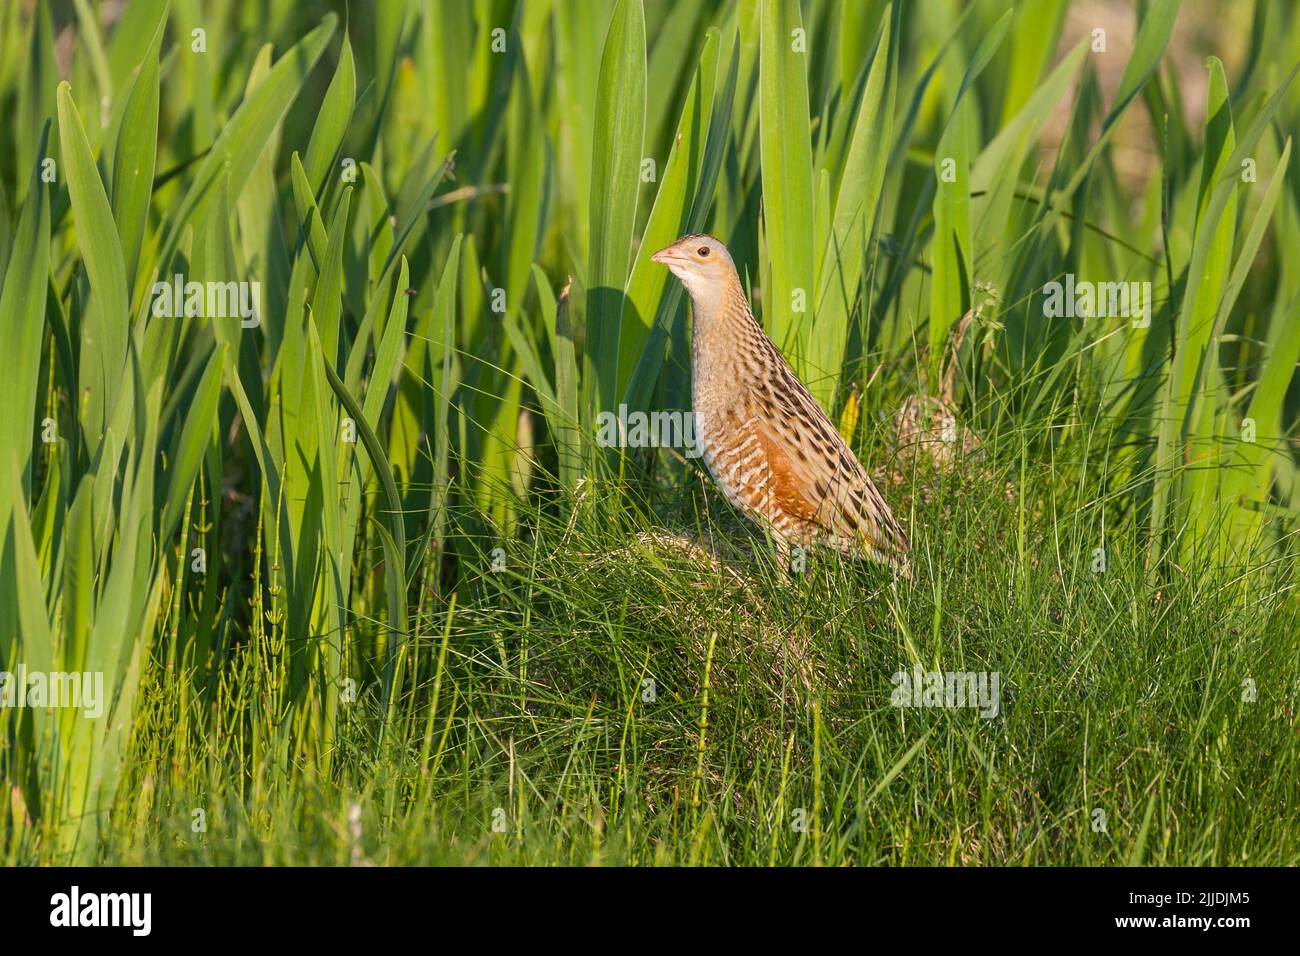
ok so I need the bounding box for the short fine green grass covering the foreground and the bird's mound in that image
[20,434,1300,865]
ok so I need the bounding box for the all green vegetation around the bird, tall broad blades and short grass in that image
[0,0,1300,865]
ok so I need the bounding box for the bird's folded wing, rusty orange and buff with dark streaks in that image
[746,363,907,564]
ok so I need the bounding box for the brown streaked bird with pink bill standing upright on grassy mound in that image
[650,233,910,576]
